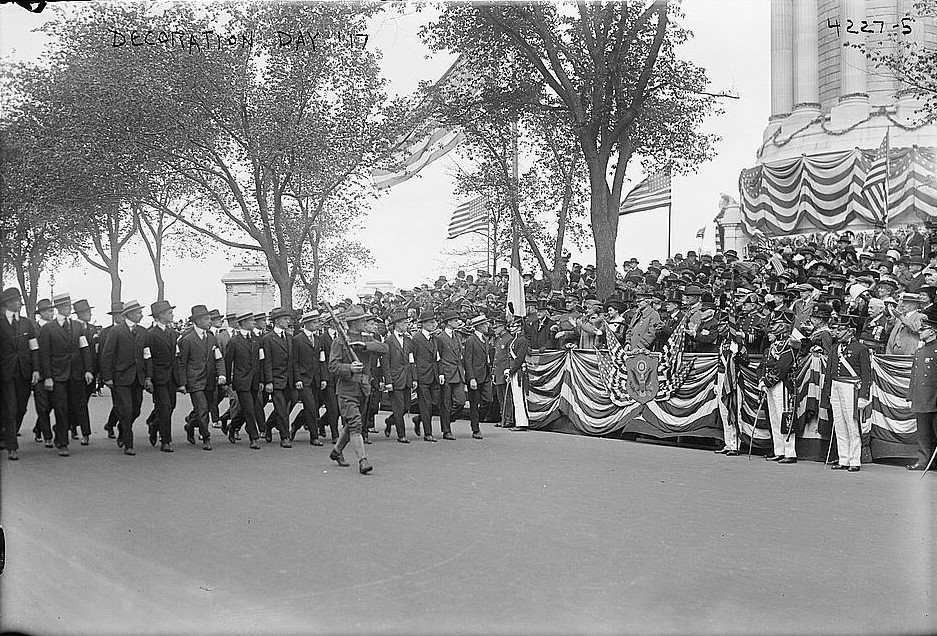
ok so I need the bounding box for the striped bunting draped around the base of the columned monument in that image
[739,148,937,236]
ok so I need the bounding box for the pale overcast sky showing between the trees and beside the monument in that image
[0,0,770,323]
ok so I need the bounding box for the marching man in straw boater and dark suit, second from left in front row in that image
[39,293,94,457]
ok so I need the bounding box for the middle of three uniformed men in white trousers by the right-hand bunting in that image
[758,312,797,464]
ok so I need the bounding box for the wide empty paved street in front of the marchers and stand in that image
[0,398,937,634]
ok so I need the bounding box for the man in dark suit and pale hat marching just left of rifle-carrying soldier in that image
[290,310,324,446]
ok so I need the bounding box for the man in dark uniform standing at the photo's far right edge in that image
[908,307,937,470]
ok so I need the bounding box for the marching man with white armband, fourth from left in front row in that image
[143,300,185,453]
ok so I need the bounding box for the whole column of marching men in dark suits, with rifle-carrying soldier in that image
[0,288,527,474]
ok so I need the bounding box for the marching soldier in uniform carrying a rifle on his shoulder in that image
[329,305,387,475]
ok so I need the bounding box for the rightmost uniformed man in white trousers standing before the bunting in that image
[829,314,872,472]
